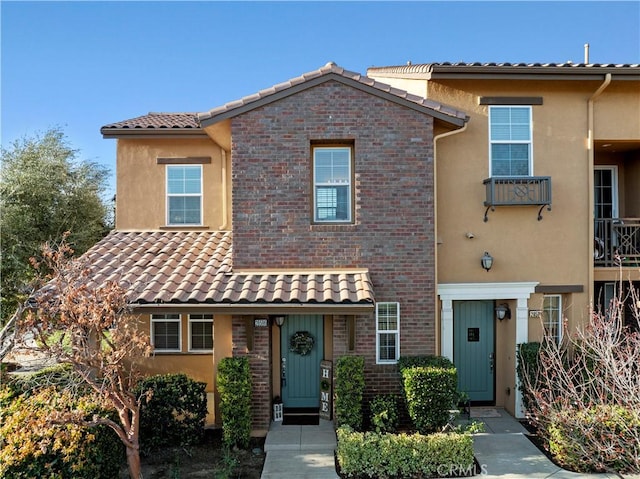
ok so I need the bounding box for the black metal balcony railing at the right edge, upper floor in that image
[593,218,640,267]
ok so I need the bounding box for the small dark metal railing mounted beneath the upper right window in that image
[483,176,551,221]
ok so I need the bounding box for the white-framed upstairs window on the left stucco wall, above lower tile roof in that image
[167,165,202,225]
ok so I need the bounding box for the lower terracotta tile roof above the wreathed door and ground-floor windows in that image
[83,231,374,305]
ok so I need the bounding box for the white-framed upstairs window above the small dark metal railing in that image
[489,106,533,176]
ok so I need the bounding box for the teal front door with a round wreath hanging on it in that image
[280,315,324,408]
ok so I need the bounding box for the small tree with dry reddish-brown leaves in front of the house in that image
[18,241,151,479]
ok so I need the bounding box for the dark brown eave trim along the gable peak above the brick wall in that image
[198,72,467,128]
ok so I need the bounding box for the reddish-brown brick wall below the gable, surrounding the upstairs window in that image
[232,81,435,408]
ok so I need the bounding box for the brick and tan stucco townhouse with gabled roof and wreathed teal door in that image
[90,63,467,434]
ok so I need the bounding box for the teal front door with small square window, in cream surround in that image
[453,301,495,403]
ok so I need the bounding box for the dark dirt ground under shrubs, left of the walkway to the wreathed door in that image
[120,431,265,479]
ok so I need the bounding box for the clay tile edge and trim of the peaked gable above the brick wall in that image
[198,62,467,126]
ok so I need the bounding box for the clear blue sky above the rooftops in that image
[0,0,640,197]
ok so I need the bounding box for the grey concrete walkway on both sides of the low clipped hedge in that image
[261,408,640,479]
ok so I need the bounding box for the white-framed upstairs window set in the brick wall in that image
[313,146,351,223]
